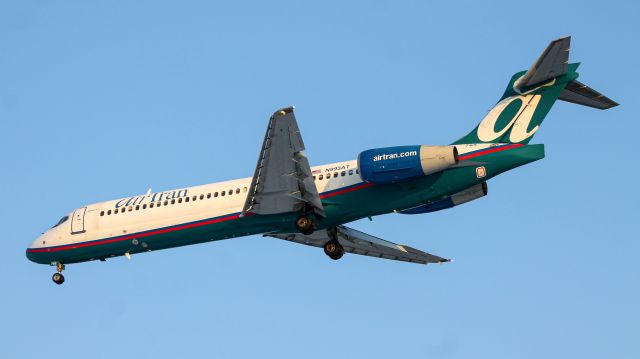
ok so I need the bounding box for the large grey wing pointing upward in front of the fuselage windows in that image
[242,107,325,217]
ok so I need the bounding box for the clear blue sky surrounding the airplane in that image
[0,1,640,358]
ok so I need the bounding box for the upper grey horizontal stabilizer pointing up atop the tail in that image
[514,36,571,89]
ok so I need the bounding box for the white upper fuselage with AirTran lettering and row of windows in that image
[30,160,362,256]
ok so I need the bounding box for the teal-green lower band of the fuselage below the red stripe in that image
[27,145,544,264]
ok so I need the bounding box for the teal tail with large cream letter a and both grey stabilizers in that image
[453,36,618,145]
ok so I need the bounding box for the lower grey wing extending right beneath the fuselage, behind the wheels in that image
[265,226,450,264]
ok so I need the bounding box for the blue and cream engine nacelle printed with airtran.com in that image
[358,145,458,184]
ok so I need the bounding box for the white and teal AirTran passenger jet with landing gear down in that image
[26,37,618,284]
